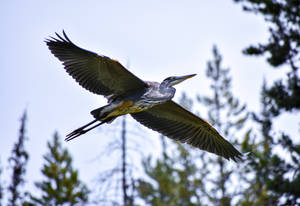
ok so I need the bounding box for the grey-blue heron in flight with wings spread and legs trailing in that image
[45,31,242,161]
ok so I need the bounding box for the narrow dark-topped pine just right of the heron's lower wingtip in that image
[240,80,279,206]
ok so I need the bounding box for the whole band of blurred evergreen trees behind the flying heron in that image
[0,0,300,206]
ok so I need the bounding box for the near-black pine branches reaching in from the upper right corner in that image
[234,0,300,114]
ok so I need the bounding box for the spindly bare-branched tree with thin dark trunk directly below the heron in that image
[94,116,141,206]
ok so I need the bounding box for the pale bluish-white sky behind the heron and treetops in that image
[0,0,299,203]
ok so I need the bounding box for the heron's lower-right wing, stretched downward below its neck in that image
[131,101,242,161]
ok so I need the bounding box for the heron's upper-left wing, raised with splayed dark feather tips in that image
[45,31,146,96]
